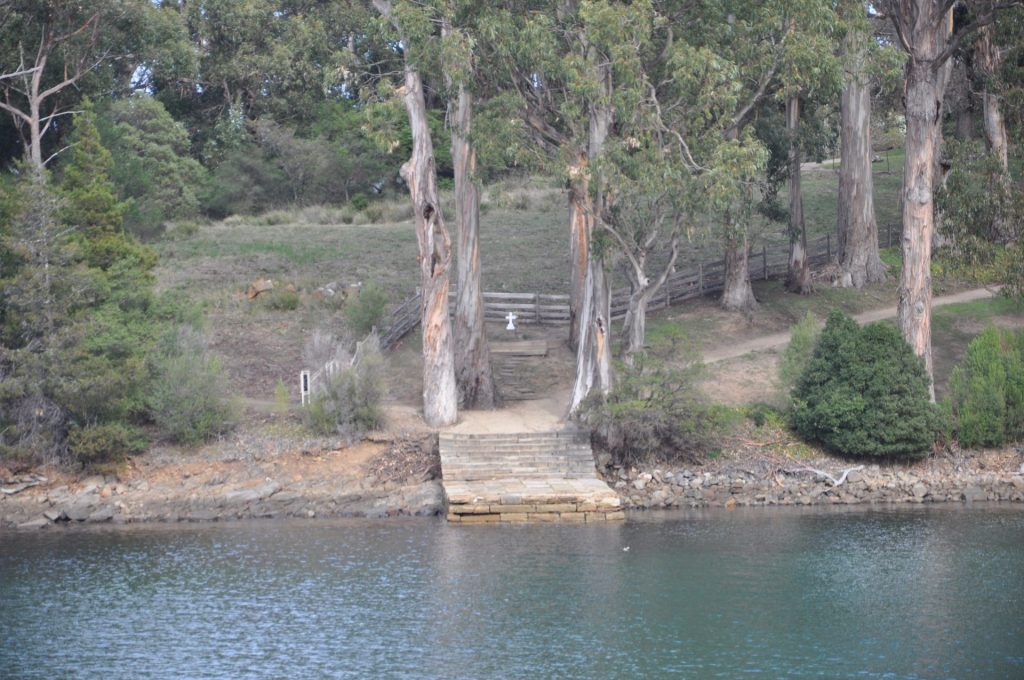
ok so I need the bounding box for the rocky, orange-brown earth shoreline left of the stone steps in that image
[0,437,444,529]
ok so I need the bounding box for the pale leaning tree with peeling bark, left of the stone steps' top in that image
[374,0,459,427]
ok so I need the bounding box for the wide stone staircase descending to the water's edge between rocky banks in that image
[439,429,624,523]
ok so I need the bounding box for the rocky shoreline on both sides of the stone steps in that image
[0,436,1024,529]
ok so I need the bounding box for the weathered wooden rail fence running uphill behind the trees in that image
[381,224,899,349]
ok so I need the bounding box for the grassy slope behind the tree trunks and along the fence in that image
[158,152,1019,409]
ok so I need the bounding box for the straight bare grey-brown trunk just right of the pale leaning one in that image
[451,86,498,409]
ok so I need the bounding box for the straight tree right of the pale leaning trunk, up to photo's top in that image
[442,5,498,409]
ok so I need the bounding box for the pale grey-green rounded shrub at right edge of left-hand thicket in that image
[146,327,236,445]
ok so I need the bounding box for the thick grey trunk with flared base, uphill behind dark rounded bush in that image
[837,11,886,288]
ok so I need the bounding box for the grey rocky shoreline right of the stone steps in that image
[598,453,1024,509]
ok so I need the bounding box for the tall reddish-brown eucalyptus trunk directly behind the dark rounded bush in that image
[880,0,1022,399]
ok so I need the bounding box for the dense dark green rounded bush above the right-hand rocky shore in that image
[792,311,940,457]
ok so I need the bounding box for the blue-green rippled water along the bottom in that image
[0,507,1024,679]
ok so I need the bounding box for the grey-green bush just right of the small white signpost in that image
[305,334,384,441]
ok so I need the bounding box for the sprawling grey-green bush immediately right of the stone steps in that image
[578,330,726,465]
